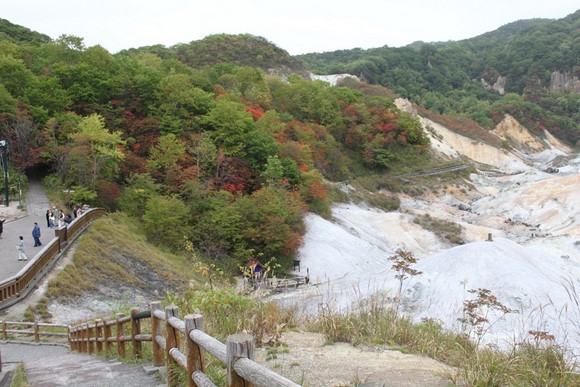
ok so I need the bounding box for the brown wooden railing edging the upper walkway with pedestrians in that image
[0,208,106,310]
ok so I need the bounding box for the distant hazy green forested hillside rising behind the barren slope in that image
[299,11,580,145]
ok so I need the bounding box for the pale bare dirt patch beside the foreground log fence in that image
[255,332,454,387]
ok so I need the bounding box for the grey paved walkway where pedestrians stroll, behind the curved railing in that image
[0,180,55,281]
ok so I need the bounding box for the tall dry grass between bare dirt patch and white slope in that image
[309,294,580,386]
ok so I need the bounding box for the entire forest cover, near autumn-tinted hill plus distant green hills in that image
[0,12,580,267]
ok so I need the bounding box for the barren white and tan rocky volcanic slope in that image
[276,101,580,366]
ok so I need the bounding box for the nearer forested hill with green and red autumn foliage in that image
[0,21,428,268]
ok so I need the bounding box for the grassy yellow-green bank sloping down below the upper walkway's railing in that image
[46,214,193,299]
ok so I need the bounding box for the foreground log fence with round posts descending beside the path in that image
[69,302,299,387]
